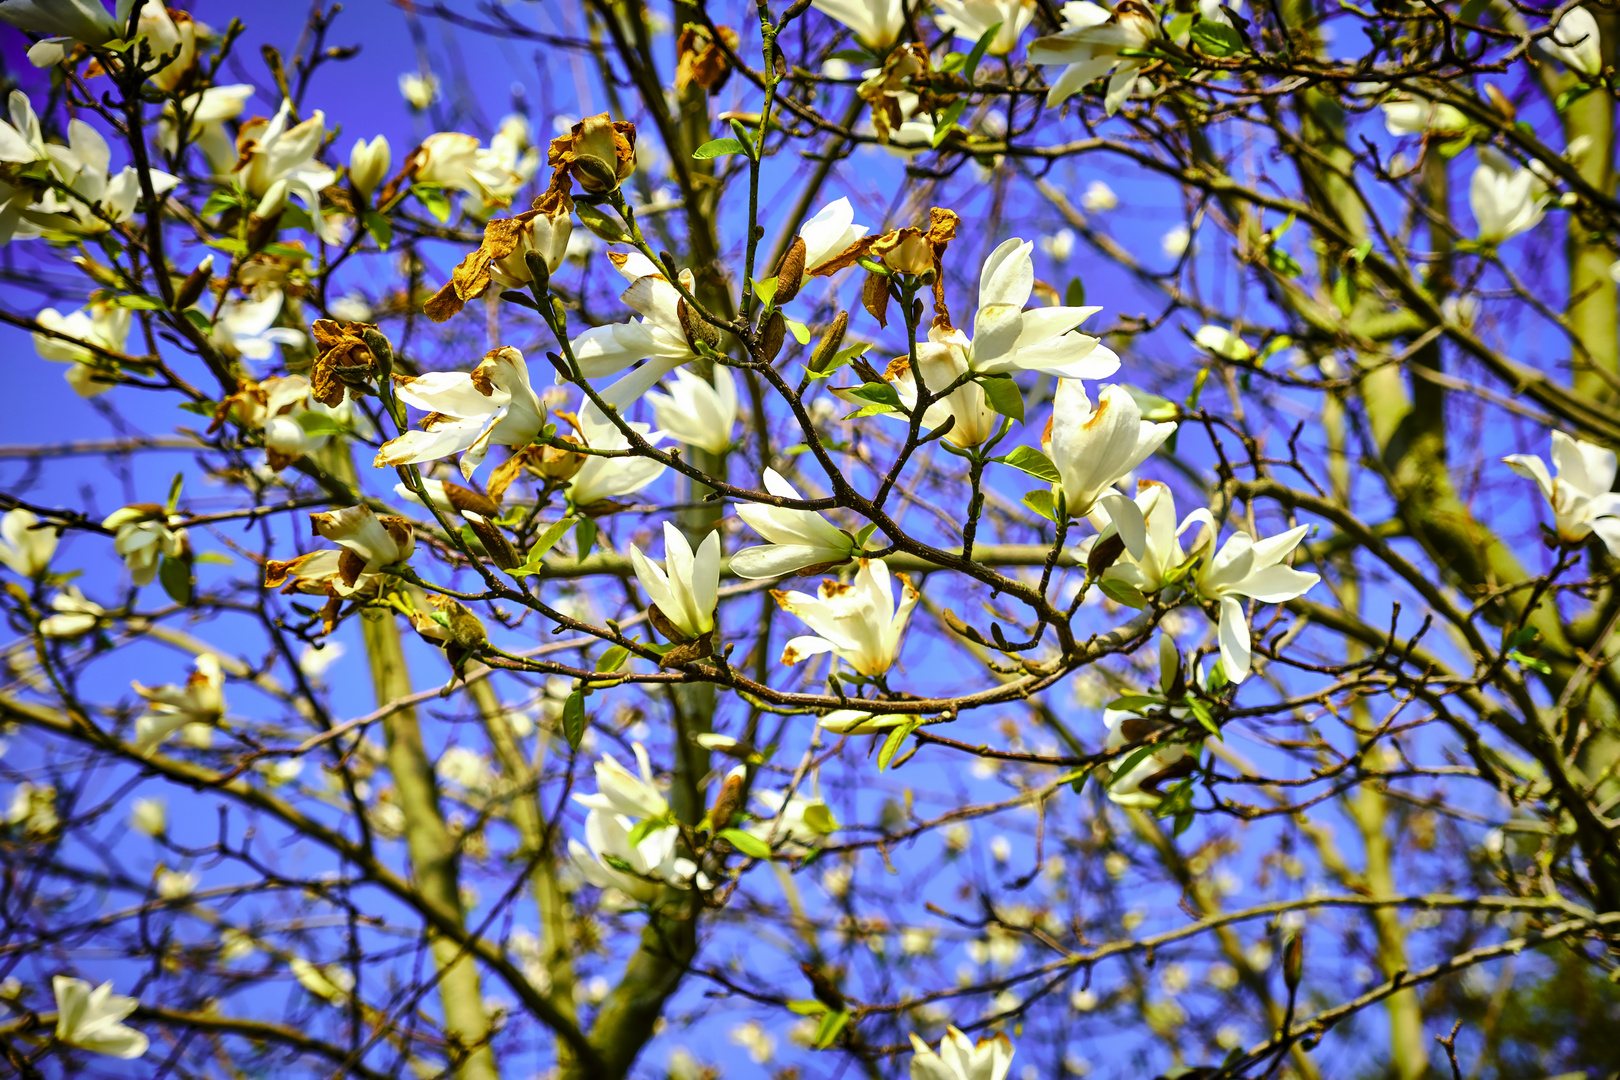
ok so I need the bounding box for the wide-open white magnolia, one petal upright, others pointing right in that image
[967,236,1119,379]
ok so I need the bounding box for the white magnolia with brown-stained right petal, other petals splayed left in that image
[376,347,546,478]
